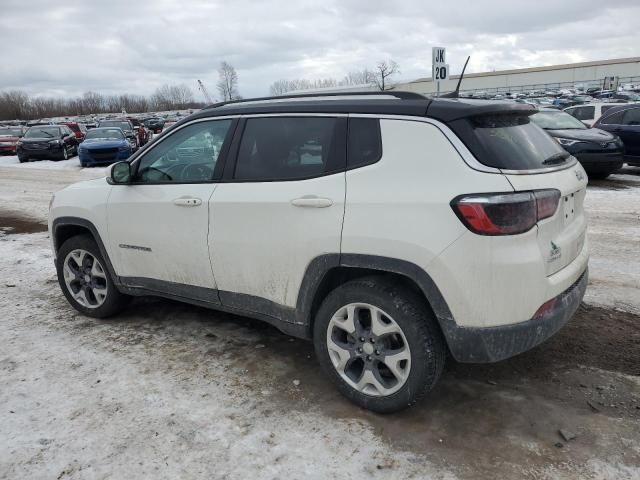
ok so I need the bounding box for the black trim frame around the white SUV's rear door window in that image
[220,112,349,183]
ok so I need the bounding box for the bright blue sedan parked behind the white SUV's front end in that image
[78,127,133,167]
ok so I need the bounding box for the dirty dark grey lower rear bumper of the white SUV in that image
[445,270,589,363]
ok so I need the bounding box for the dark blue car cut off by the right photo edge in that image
[593,103,640,166]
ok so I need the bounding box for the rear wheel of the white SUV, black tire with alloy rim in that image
[313,277,446,413]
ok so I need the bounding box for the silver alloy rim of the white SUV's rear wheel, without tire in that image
[327,303,411,397]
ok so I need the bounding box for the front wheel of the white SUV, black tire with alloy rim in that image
[56,235,129,318]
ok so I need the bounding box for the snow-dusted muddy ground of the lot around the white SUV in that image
[0,161,640,479]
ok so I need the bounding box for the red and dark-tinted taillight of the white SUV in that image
[451,190,560,235]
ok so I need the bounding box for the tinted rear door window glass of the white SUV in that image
[234,117,344,181]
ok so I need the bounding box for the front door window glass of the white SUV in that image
[134,120,232,183]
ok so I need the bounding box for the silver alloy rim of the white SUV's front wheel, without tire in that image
[62,249,108,308]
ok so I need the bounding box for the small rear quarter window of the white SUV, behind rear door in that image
[347,118,382,168]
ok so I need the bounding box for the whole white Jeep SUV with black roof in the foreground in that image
[49,92,588,412]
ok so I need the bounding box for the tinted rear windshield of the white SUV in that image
[451,114,570,170]
